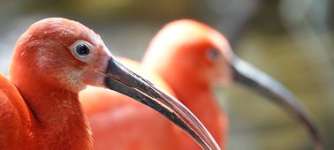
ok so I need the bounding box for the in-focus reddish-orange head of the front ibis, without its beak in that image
[11,18,111,92]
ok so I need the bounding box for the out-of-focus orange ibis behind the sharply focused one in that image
[80,20,321,150]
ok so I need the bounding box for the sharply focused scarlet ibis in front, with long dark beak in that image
[0,18,219,150]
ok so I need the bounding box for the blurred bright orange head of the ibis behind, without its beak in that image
[143,19,233,86]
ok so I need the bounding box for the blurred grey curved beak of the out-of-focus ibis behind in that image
[231,56,323,150]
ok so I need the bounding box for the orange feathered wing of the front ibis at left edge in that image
[0,74,31,149]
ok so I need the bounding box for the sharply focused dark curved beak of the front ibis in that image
[105,58,220,150]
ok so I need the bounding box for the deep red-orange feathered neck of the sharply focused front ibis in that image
[14,77,91,149]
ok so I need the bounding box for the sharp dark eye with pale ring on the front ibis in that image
[70,40,93,61]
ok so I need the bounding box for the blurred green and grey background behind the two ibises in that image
[0,0,334,150]
